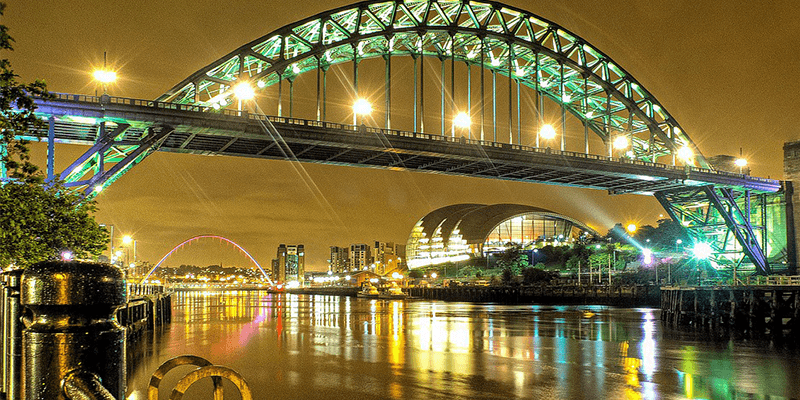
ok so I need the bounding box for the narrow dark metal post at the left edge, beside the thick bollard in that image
[3,269,22,400]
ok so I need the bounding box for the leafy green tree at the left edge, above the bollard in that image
[0,3,108,268]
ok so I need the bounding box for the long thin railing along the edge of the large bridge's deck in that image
[40,93,778,184]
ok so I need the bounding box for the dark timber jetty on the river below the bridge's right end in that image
[661,276,800,339]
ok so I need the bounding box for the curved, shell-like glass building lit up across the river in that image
[406,204,600,269]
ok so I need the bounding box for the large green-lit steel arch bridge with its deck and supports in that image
[7,0,787,274]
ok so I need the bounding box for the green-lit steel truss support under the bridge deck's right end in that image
[654,185,782,275]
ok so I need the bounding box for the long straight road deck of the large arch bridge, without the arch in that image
[34,94,781,194]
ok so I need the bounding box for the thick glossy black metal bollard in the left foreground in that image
[21,261,126,400]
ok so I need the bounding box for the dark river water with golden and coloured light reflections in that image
[128,292,800,400]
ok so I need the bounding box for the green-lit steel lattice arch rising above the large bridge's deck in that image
[158,0,709,168]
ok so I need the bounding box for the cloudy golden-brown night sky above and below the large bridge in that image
[3,0,800,270]
